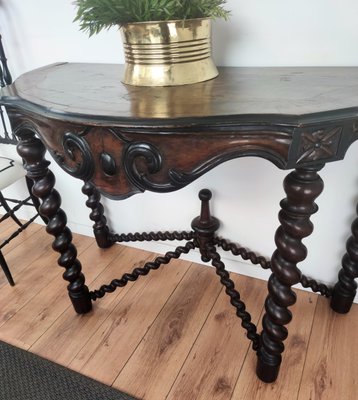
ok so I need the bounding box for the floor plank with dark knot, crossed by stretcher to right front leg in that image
[167,274,267,400]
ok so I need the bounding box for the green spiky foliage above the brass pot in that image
[75,0,229,36]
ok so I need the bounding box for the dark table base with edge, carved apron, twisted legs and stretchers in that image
[4,64,358,382]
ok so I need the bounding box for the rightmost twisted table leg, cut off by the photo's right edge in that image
[331,206,358,314]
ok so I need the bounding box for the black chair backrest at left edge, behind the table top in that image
[0,35,18,144]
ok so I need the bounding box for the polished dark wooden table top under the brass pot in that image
[1,63,358,124]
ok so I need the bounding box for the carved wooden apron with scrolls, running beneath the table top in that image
[11,111,352,199]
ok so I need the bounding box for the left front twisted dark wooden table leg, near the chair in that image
[17,129,92,314]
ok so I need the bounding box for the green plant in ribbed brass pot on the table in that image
[75,0,229,86]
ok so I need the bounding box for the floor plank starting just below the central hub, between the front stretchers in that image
[113,264,222,400]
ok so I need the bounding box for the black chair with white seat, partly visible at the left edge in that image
[0,35,40,286]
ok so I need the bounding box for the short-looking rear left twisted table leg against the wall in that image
[82,182,114,248]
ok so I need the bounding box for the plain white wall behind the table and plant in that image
[0,0,358,300]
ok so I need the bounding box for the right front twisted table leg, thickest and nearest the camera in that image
[256,168,323,382]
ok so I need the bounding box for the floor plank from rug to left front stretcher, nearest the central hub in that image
[69,260,190,384]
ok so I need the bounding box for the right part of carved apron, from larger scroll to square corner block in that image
[122,127,291,192]
